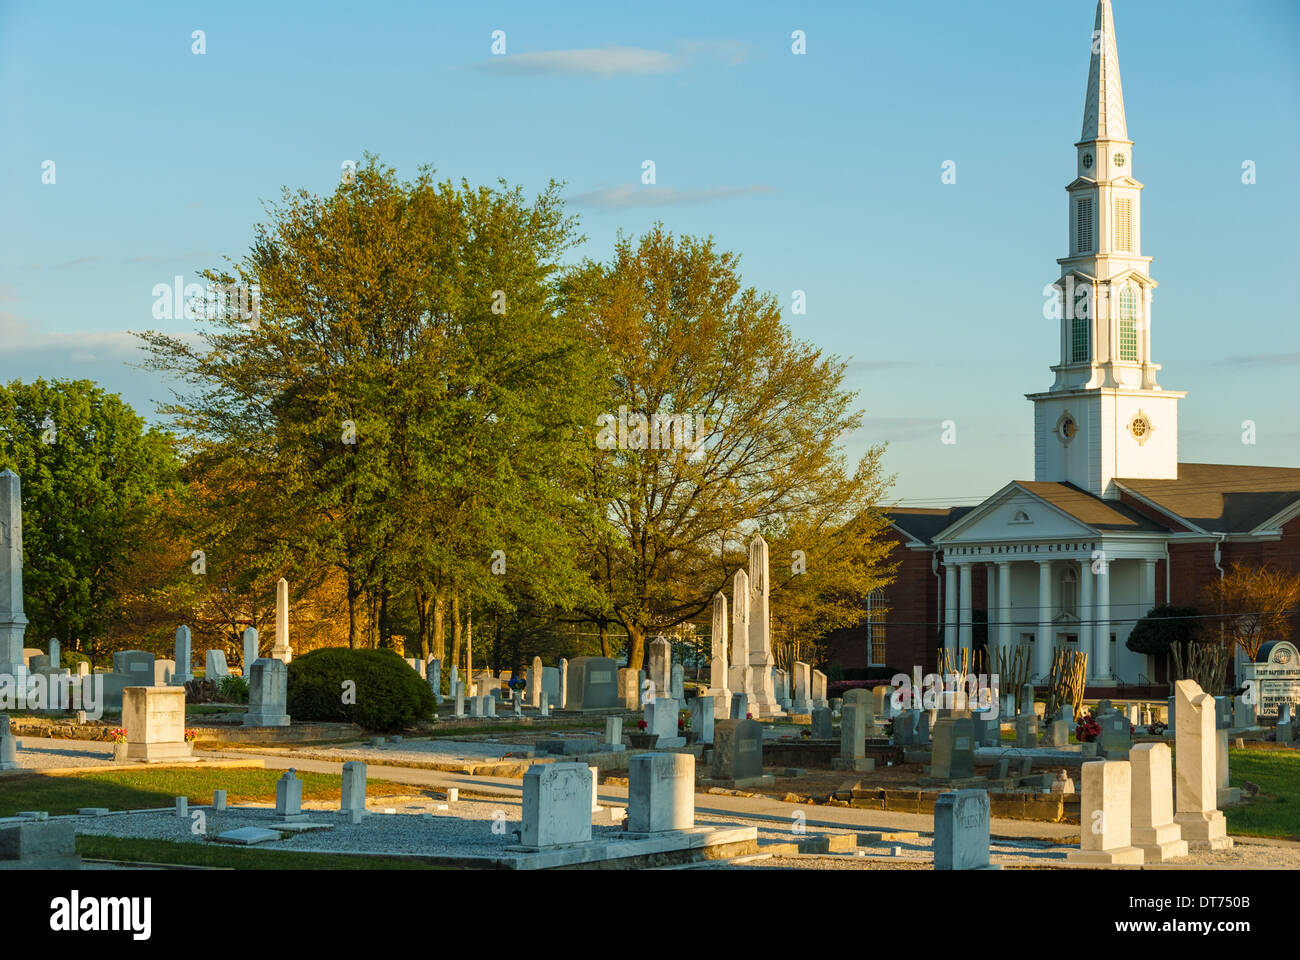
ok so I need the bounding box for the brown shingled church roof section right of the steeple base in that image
[1115,463,1300,533]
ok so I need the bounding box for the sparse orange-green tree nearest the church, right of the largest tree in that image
[568,225,891,666]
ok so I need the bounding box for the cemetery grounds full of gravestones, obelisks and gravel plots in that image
[0,475,1300,870]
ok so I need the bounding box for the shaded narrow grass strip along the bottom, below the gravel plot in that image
[77,835,446,870]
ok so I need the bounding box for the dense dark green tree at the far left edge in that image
[0,380,186,653]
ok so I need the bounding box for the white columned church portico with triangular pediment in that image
[933,481,1167,686]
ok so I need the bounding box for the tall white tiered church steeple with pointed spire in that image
[1027,0,1186,496]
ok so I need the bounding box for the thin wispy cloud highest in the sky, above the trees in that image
[471,39,749,77]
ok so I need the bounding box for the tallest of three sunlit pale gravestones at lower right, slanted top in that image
[1174,680,1232,851]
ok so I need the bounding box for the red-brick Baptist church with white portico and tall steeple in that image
[831,0,1300,696]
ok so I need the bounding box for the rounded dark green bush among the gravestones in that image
[289,647,434,732]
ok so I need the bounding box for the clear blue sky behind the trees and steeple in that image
[0,0,1300,505]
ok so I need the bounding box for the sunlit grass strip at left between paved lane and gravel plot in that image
[0,766,432,817]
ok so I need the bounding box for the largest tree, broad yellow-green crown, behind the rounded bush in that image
[134,157,594,649]
